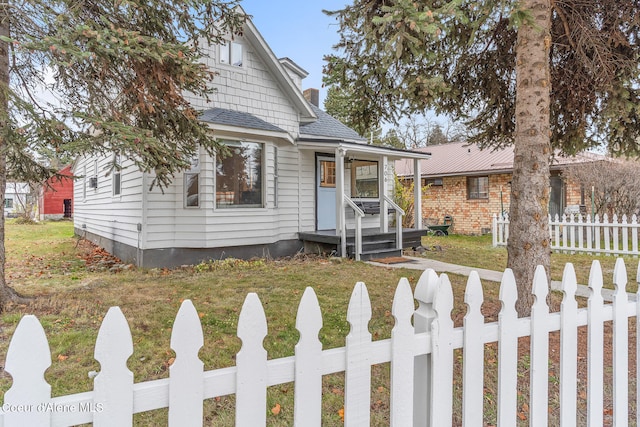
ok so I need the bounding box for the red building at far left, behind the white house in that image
[38,165,73,220]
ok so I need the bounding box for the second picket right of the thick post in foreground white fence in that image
[462,271,484,426]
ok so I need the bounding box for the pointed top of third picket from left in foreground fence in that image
[171,300,204,363]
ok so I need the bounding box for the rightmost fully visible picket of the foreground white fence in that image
[612,258,629,427]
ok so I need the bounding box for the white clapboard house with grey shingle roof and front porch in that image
[74,10,429,267]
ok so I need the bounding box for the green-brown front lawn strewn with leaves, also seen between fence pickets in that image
[0,222,636,427]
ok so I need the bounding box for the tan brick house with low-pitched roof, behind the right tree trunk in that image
[395,142,604,235]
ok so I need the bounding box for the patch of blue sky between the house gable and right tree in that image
[236,0,351,107]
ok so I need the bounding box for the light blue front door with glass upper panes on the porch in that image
[316,156,336,230]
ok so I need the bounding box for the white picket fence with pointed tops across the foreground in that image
[0,260,640,427]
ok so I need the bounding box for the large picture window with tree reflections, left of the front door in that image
[216,142,264,208]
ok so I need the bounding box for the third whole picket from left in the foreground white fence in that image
[169,300,204,427]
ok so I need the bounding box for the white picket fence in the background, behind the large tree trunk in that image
[492,214,640,256]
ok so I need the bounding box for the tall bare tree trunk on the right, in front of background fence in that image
[507,0,551,317]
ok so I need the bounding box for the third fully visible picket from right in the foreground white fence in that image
[560,263,578,427]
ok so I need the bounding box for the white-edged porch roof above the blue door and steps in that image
[297,138,431,160]
